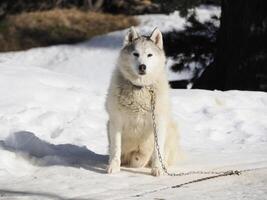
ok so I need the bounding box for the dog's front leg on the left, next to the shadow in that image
[107,121,121,174]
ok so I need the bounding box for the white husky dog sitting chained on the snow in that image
[106,27,178,176]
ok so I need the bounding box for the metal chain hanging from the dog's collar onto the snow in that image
[149,86,243,178]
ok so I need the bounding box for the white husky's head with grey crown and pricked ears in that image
[118,27,166,86]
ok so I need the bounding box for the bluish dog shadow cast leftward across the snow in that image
[0,131,108,173]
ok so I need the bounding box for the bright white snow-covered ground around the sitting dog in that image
[0,8,267,200]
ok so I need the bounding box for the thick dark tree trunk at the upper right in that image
[194,0,267,91]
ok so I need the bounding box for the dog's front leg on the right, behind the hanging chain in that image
[151,117,166,176]
